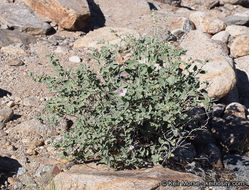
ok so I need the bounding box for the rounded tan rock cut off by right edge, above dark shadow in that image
[230,34,249,58]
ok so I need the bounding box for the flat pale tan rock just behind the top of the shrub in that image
[74,27,139,48]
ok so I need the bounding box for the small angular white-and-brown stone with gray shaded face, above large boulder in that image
[169,17,195,38]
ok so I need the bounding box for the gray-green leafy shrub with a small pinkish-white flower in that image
[31,33,213,168]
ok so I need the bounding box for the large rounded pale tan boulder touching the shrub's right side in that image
[180,30,236,99]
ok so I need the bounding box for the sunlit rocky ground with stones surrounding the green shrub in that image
[0,0,249,190]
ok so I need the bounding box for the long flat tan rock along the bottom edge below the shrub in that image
[47,165,202,190]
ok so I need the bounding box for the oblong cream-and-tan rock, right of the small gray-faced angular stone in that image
[189,11,226,34]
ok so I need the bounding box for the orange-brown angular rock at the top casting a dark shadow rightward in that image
[23,0,90,30]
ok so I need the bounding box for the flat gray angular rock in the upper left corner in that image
[0,4,52,35]
